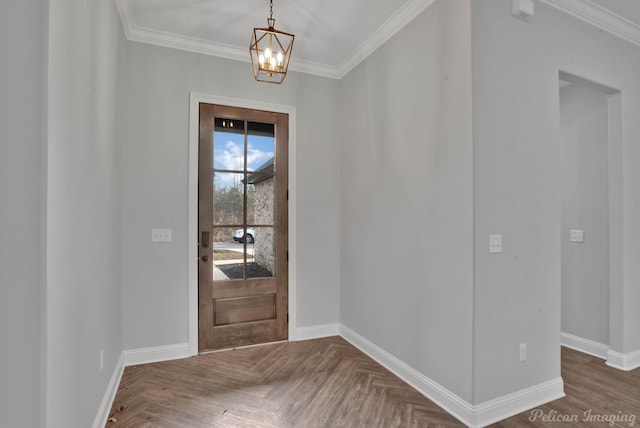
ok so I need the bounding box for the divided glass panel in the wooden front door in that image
[212,118,275,281]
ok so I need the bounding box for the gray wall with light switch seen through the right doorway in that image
[560,84,609,345]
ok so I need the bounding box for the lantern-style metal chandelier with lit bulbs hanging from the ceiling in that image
[249,0,295,83]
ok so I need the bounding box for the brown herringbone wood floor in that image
[107,337,640,428]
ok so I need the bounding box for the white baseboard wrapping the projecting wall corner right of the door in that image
[339,325,564,428]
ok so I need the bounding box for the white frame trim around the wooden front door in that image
[187,92,297,356]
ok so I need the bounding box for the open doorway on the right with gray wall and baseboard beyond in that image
[559,72,622,360]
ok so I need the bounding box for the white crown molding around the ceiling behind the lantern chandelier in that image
[115,0,434,79]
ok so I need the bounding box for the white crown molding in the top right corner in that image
[539,0,640,46]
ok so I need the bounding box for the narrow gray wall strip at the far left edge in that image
[0,0,46,427]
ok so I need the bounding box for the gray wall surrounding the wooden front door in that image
[119,42,340,349]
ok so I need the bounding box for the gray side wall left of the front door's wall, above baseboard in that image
[46,0,123,428]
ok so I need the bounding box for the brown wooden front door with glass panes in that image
[198,103,289,352]
